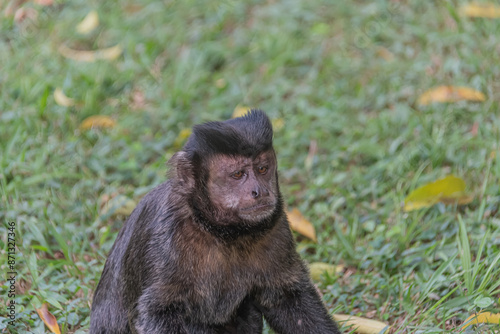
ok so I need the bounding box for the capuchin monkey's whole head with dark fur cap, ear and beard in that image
[172,110,282,238]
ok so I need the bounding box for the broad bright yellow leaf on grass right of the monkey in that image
[404,175,473,211]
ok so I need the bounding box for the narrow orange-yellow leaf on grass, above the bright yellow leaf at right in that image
[418,86,486,105]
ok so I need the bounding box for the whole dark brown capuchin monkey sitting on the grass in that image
[90,110,340,334]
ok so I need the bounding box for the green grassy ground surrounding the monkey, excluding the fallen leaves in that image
[0,0,500,333]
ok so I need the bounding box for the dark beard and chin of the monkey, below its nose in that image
[191,190,284,241]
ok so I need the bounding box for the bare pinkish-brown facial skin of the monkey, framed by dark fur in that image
[207,150,278,222]
